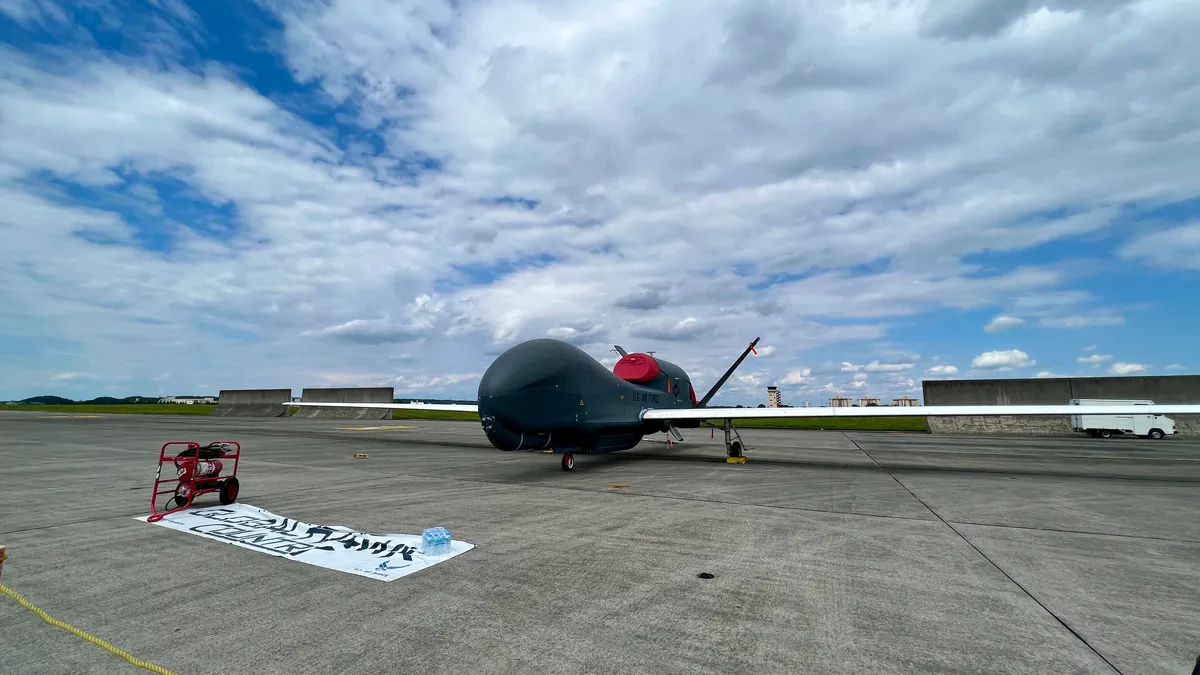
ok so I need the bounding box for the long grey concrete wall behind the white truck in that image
[922,375,1200,436]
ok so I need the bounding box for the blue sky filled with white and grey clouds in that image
[0,0,1200,404]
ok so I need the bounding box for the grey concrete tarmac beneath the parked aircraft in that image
[0,413,1200,675]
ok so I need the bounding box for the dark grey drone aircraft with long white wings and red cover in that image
[286,338,1200,471]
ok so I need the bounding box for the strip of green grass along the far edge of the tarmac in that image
[0,404,926,431]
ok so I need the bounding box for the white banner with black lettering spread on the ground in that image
[134,503,475,581]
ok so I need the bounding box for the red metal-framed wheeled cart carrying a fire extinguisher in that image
[146,441,241,522]
